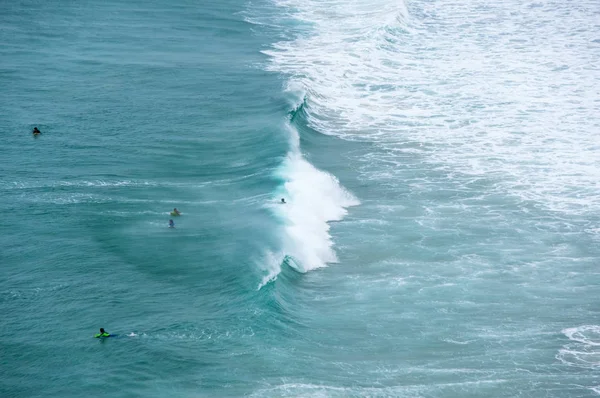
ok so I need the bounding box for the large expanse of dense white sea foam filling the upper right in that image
[265,0,600,214]
